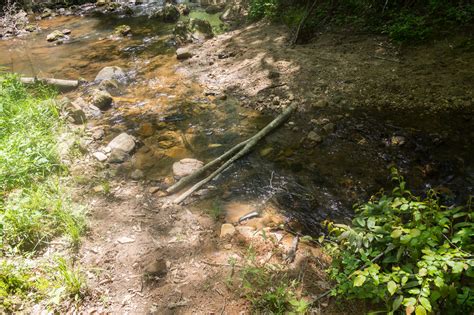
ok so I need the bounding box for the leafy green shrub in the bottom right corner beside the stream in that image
[327,170,474,315]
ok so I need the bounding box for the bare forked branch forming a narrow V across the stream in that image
[167,103,297,204]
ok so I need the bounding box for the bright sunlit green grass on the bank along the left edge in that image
[0,73,85,313]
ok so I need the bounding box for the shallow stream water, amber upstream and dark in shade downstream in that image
[0,8,474,236]
